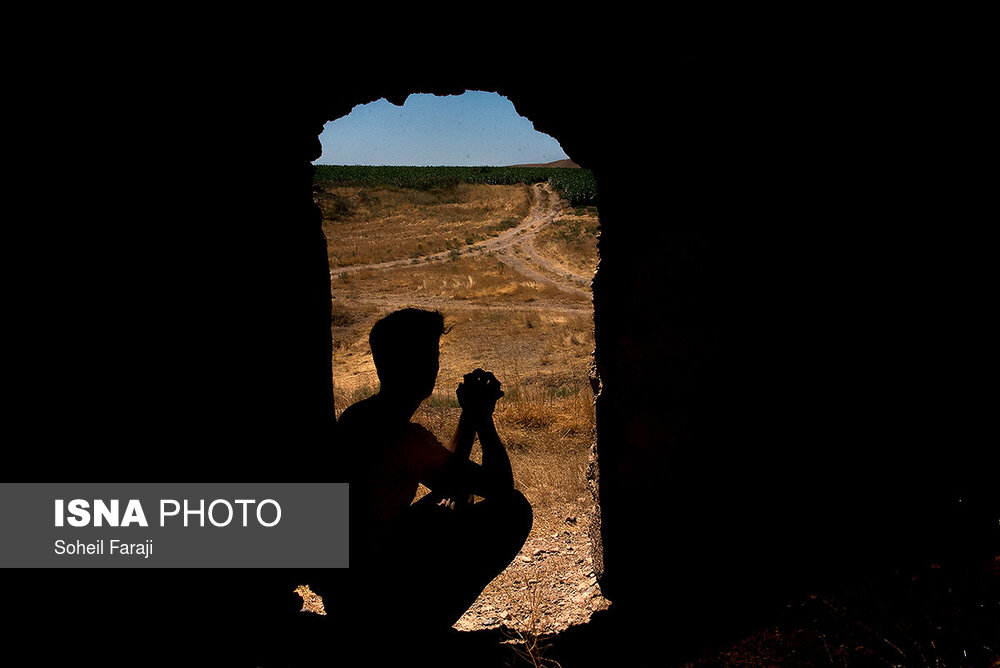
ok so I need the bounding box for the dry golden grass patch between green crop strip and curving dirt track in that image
[315,184,533,268]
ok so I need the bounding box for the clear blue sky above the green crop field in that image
[314,91,568,166]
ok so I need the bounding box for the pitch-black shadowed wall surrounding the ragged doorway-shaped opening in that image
[15,52,995,664]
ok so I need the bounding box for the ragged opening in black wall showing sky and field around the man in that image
[314,91,608,633]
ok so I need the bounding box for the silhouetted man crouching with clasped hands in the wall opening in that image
[338,309,532,630]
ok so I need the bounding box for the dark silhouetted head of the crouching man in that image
[368,308,444,399]
